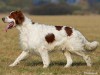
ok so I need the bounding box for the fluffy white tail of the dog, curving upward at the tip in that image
[85,41,99,51]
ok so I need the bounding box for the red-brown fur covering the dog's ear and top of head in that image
[9,11,24,24]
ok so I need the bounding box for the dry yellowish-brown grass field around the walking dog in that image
[0,14,100,75]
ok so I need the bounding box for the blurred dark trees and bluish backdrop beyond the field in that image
[0,0,100,15]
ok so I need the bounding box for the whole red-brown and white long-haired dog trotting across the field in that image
[2,11,99,68]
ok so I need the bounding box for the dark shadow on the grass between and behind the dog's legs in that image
[27,61,86,66]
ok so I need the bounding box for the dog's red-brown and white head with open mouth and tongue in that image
[2,11,24,31]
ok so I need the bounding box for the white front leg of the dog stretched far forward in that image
[9,51,29,67]
